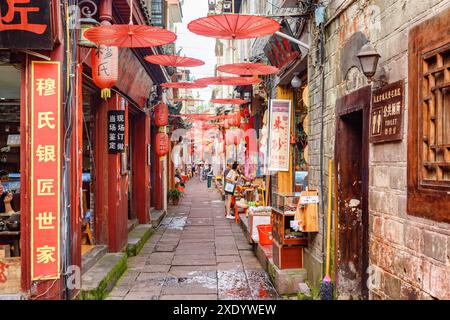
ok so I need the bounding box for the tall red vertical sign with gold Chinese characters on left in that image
[31,61,61,280]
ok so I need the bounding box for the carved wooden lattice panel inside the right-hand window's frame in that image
[421,45,450,186]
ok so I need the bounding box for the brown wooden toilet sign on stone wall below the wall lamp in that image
[370,80,404,143]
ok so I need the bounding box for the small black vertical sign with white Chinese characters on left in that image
[108,110,125,154]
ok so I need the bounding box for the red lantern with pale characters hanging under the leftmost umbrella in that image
[91,22,119,99]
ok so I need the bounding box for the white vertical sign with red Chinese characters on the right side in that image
[268,100,291,171]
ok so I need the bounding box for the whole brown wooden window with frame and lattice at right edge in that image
[408,9,450,222]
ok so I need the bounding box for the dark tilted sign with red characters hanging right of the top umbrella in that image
[264,21,300,69]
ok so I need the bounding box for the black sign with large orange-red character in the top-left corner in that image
[0,0,53,50]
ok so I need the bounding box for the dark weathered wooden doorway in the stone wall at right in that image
[335,87,371,299]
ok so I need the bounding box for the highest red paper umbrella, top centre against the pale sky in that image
[188,14,280,40]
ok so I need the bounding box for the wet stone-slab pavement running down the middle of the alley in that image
[108,178,278,300]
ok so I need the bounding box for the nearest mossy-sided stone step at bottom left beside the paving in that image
[77,252,127,300]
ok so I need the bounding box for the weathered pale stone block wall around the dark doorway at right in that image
[305,0,450,299]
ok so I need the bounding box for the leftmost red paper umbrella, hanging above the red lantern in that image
[85,24,177,48]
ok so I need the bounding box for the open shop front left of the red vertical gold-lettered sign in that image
[0,57,22,296]
